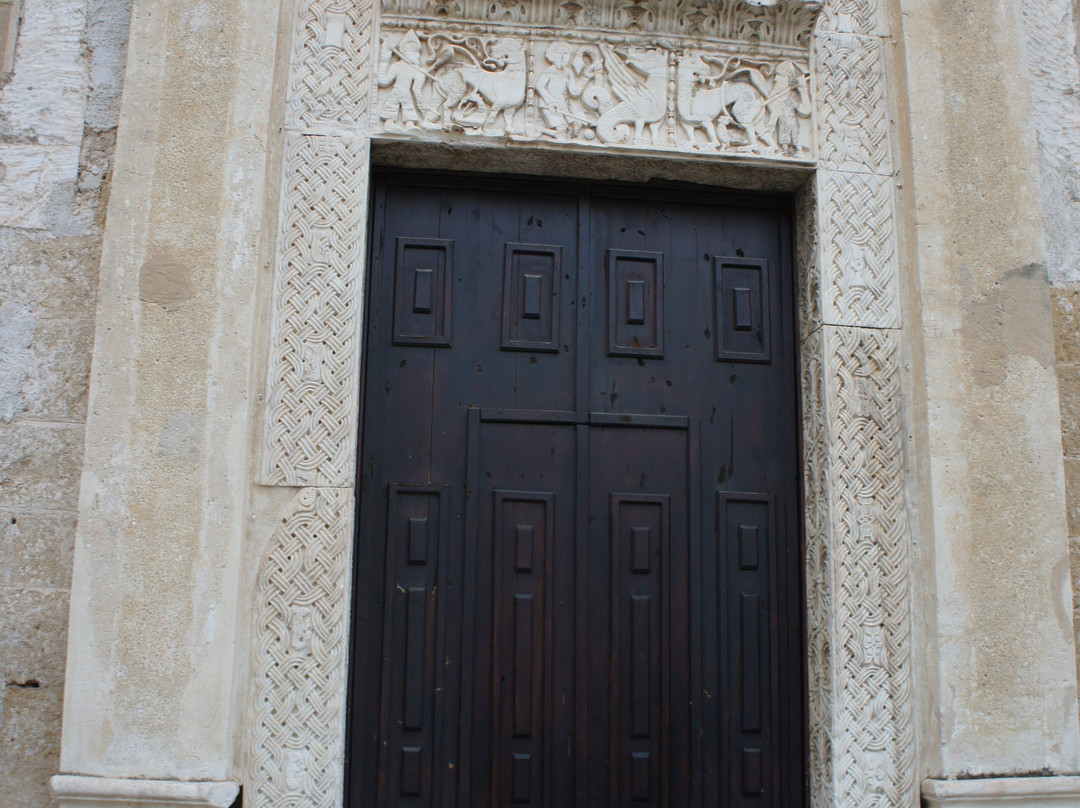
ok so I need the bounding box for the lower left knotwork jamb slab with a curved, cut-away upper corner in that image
[244,488,353,808]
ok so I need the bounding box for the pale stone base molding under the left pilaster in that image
[49,775,240,808]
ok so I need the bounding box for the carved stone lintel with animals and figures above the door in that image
[373,0,813,160]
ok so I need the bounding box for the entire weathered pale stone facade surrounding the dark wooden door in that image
[0,0,1080,808]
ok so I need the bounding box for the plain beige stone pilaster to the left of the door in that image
[62,0,278,780]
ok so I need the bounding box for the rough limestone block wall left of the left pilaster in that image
[0,0,131,808]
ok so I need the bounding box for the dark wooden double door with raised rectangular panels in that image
[349,175,805,808]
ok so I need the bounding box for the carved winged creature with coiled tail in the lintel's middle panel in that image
[596,44,667,146]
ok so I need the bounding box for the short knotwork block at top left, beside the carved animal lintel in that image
[288,0,375,131]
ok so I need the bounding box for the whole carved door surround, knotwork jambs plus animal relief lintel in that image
[248,0,917,808]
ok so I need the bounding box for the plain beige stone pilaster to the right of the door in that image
[901,0,1080,776]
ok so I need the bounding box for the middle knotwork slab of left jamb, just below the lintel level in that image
[264,136,368,486]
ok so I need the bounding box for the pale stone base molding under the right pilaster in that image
[922,777,1080,808]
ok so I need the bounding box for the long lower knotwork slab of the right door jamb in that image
[808,326,915,808]
